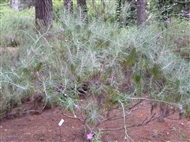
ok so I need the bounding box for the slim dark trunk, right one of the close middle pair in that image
[77,0,88,23]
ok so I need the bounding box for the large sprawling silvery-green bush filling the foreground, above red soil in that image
[0,5,190,139]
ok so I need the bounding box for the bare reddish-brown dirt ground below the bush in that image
[0,100,190,142]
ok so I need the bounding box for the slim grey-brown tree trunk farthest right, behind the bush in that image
[137,0,146,26]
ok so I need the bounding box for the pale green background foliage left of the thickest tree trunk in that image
[0,8,35,47]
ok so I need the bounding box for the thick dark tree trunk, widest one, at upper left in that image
[35,0,53,31]
